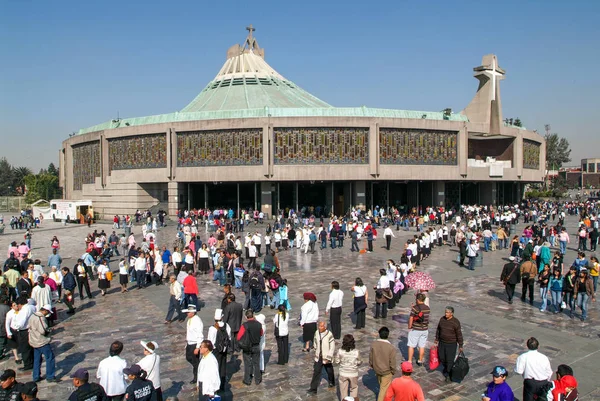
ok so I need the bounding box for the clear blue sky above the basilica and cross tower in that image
[0,0,600,171]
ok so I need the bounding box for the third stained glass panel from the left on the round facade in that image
[177,128,263,167]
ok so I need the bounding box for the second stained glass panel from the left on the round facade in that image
[108,134,167,171]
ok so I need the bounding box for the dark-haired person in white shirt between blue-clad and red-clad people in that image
[515,337,552,401]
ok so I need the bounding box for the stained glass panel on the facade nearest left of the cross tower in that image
[379,128,458,166]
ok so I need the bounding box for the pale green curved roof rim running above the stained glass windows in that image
[79,107,469,134]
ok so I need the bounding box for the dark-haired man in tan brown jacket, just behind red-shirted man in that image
[369,326,397,401]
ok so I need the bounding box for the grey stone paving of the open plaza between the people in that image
[0,217,600,401]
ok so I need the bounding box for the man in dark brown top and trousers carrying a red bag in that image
[434,306,464,383]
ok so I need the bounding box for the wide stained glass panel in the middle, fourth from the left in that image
[274,128,369,164]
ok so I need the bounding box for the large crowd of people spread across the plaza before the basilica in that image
[0,198,600,401]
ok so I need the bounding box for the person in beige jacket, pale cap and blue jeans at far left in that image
[29,304,60,382]
